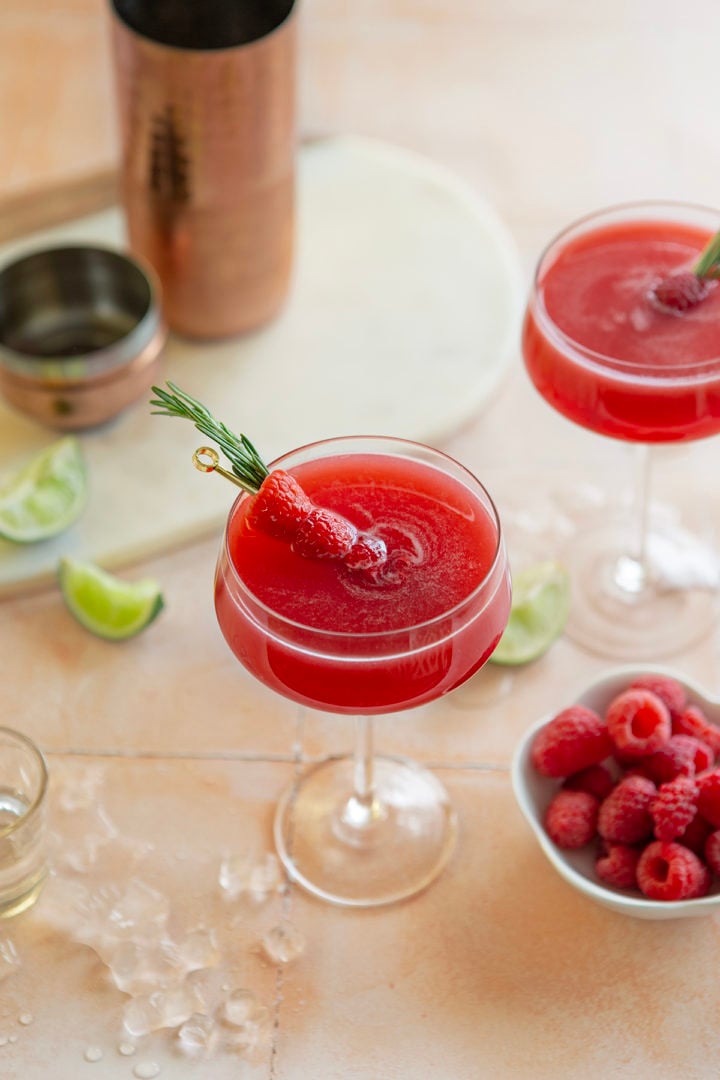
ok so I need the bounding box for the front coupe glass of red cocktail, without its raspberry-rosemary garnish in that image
[215,436,511,906]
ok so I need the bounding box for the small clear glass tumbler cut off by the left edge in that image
[0,727,47,919]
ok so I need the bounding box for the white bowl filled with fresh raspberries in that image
[512,666,720,919]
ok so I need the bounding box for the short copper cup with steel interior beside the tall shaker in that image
[0,245,166,430]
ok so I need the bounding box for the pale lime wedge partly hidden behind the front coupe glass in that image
[490,563,570,665]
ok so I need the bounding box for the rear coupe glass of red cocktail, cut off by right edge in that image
[522,202,720,659]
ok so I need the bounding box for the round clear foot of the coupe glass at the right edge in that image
[562,524,720,660]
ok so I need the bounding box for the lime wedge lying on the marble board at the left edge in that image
[0,435,87,543]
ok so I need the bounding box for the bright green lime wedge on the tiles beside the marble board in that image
[58,557,163,642]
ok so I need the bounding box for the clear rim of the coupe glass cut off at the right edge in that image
[530,199,720,375]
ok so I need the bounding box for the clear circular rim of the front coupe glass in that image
[221,435,505,645]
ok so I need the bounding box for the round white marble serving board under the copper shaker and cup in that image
[0,136,522,595]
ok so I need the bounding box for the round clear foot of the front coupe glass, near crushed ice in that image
[274,757,458,907]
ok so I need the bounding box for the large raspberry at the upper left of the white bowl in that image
[530,705,612,778]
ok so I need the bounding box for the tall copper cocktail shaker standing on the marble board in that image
[111,0,296,338]
